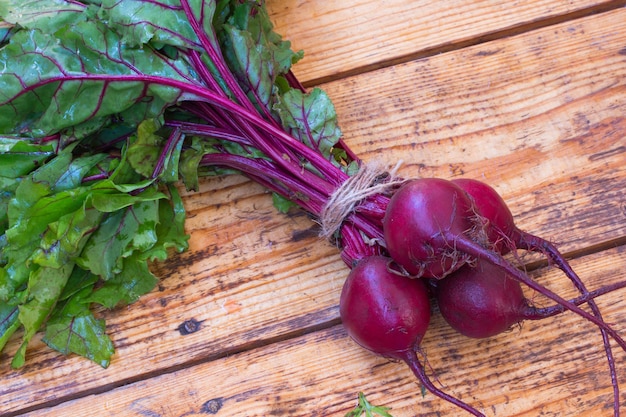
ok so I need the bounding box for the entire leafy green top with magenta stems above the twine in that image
[0,0,356,367]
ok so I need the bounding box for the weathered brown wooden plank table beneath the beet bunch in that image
[0,0,626,417]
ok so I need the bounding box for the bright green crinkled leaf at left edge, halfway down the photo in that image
[0,149,102,301]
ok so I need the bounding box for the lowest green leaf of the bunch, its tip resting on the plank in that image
[43,288,115,368]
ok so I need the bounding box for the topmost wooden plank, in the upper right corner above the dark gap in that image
[267,0,623,84]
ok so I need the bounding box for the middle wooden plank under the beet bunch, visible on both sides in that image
[0,6,626,413]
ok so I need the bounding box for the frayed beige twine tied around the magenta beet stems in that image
[318,162,404,239]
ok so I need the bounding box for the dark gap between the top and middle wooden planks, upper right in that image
[302,0,626,88]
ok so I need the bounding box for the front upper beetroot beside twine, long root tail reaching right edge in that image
[383,178,626,351]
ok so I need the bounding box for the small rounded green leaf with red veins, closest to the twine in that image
[276,88,341,161]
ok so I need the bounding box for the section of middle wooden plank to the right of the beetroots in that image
[324,10,626,254]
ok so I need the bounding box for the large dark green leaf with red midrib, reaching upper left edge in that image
[0,21,197,136]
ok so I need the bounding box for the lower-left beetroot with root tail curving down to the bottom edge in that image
[339,256,483,416]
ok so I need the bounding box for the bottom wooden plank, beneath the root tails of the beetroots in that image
[19,246,626,417]
